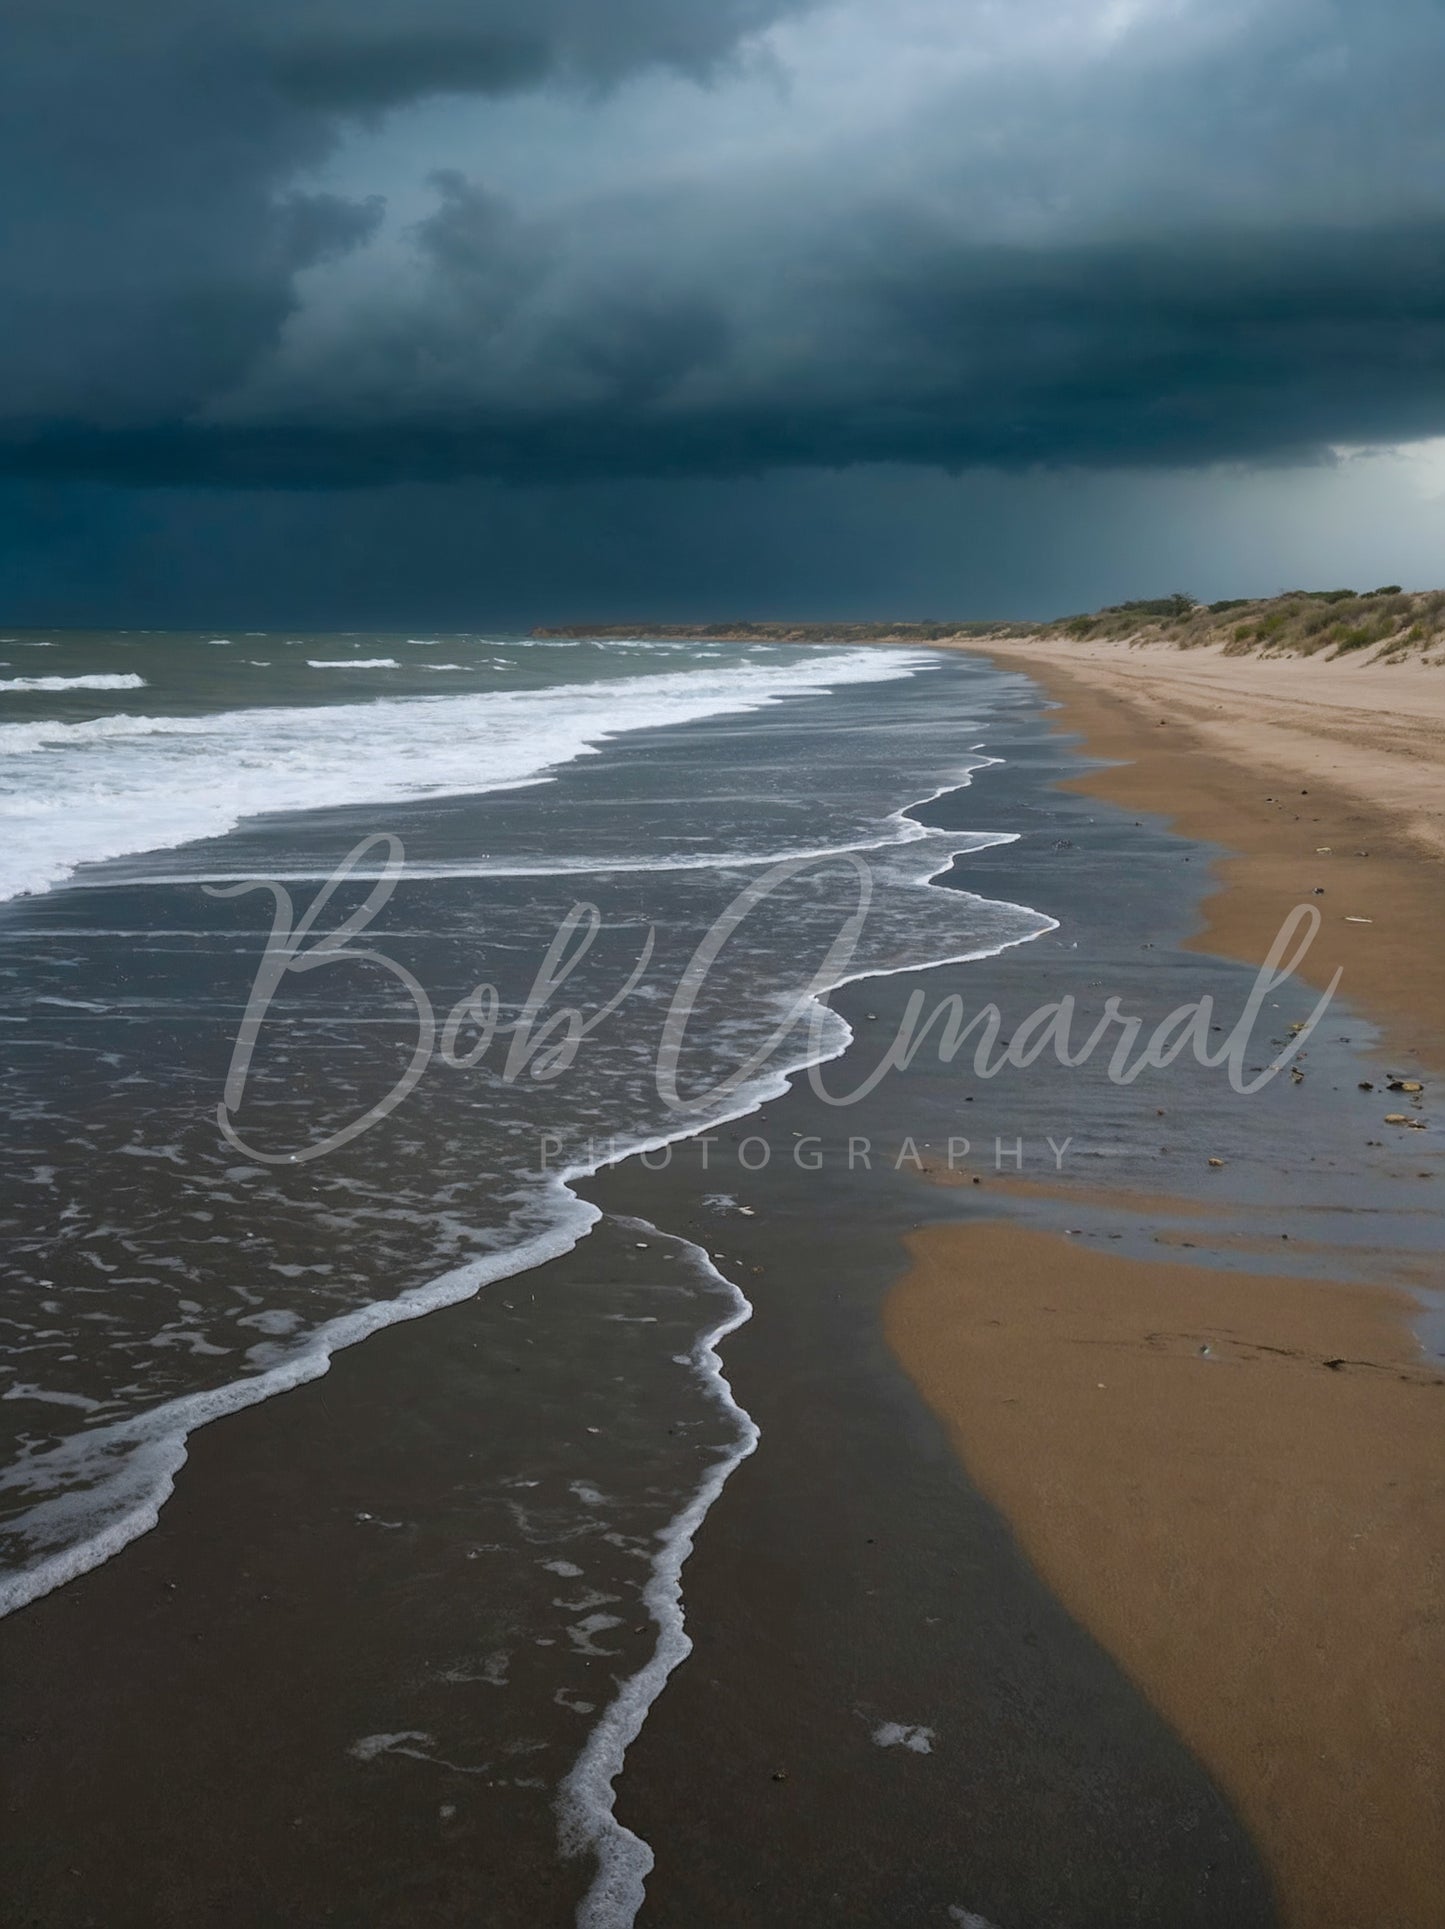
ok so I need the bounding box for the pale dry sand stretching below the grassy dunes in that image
[956,642,1445,1073]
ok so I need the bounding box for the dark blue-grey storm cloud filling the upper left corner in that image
[0,0,793,434]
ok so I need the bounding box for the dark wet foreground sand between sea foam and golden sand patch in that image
[4,1141,1275,1929]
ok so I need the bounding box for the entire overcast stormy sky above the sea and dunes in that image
[0,0,1445,627]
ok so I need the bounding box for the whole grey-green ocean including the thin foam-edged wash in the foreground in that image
[0,633,1053,1923]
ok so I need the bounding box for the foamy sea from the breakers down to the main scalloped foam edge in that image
[0,638,1050,1603]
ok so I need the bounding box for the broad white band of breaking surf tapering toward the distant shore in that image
[0,650,928,897]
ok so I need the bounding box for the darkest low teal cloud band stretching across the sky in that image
[14,215,1445,486]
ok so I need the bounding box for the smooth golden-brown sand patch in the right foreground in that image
[887,1225,1445,1929]
